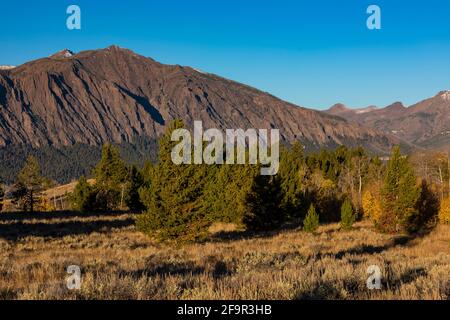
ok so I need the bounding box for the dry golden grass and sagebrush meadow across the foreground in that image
[0,213,450,299]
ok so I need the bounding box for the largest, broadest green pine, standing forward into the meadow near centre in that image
[136,121,211,242]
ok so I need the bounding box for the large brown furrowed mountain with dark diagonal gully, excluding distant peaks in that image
[0,46,395,151]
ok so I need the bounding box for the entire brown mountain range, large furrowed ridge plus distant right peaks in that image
[0,46,450,184]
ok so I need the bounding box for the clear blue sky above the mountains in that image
[0,0,450,109]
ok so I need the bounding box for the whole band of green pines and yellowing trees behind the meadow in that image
[0,121,450,241]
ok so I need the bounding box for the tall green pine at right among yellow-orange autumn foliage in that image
[377,146,420,233]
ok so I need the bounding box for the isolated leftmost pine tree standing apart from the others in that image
[12,156,49,212]
